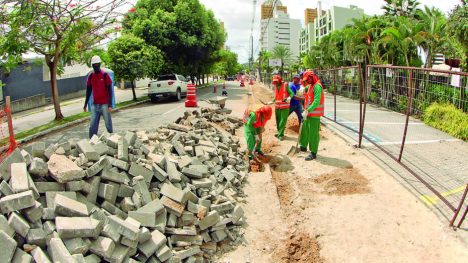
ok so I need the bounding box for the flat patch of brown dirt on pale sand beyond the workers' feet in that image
[313,169,371,195]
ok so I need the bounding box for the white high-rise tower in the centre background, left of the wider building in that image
[260,1,301,63]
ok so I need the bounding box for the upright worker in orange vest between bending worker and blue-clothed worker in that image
[272,75,294,141]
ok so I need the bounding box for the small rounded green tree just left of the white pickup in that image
[108,34,163,81]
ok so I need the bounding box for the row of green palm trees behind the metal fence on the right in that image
[301,0,468,69]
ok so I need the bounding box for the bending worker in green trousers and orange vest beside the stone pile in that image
[244,106,272,160]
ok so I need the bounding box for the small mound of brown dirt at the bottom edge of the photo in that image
[276,232,324,263]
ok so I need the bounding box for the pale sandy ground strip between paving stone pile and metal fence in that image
[219,84,468,263]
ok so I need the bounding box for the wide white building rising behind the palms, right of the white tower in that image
[300,1,365,53]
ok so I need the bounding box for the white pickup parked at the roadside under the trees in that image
[148,74,188,102]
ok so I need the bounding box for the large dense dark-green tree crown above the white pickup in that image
[123,0,225,75]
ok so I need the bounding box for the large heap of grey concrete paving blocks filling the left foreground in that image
[0,112,247,263]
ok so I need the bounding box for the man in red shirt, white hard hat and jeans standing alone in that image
[83,56,113,138]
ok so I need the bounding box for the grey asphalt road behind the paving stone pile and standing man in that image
[29,81,247,144]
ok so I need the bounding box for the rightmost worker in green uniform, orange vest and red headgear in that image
[299,71,325,161]
